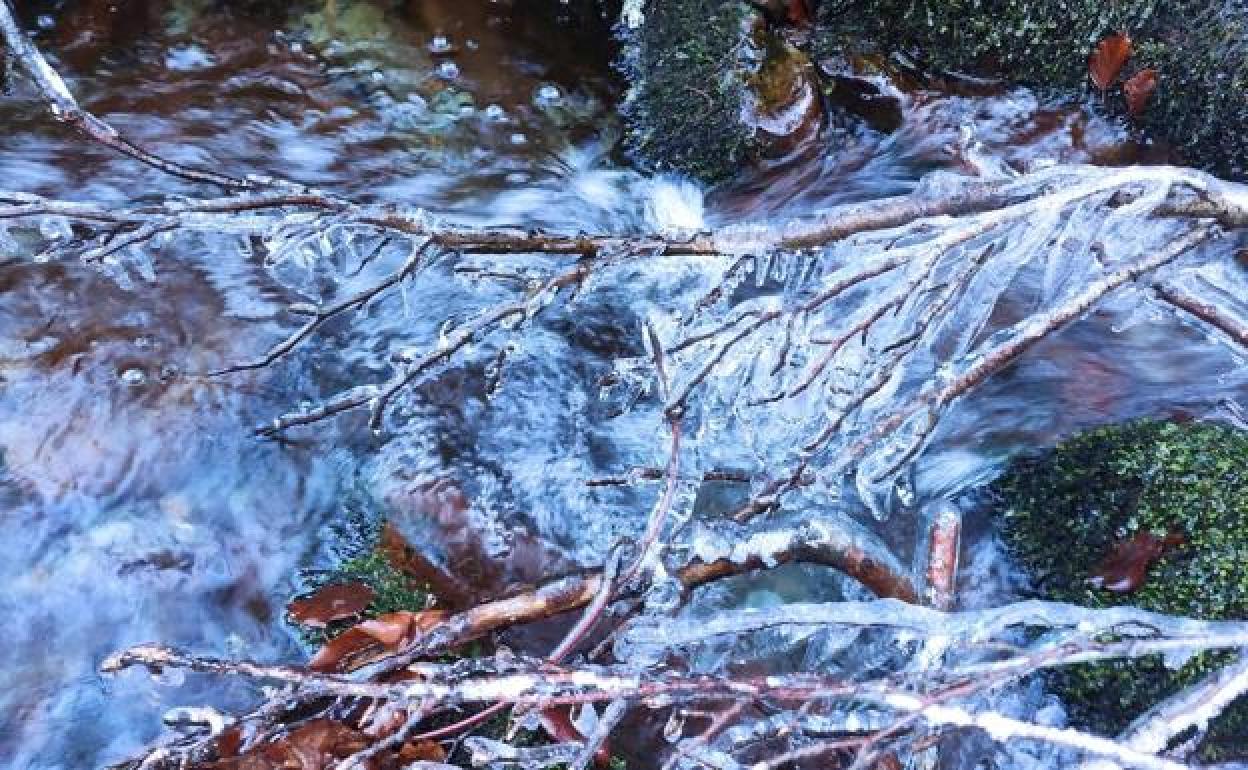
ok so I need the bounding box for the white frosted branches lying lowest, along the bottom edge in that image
[106,600,1248,770]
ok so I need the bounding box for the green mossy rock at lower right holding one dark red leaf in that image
[993,421,1248,759]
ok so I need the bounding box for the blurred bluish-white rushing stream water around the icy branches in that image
[7,0,1246,769]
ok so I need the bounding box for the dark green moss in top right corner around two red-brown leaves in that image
[814,0,1248,176]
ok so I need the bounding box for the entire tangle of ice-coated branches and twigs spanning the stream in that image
[12,14,1248,769]
